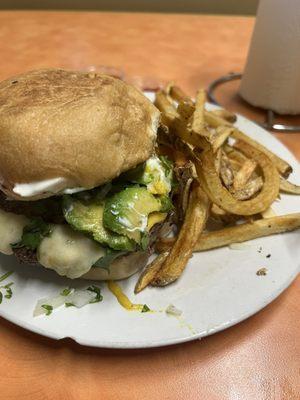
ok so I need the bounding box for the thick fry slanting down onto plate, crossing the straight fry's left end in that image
[151,186,210,286]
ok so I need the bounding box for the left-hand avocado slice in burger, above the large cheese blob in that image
[63,196,135,251]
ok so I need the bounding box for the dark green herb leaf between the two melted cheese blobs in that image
[11,217,51,250]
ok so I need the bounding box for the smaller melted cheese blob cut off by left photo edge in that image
[0,209,28,254]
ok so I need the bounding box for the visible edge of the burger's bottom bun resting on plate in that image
[80,251,149,281]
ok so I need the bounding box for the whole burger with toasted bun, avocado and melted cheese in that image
[0,69,174,280]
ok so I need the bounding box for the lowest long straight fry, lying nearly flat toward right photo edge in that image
[159,213,300,252]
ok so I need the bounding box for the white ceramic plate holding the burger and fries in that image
[0,97,300,348]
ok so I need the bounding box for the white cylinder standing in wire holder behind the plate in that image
[239,0,300,114]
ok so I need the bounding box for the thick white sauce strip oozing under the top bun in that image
[13,177,86,197]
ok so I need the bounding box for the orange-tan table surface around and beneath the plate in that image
[0,11,300,400]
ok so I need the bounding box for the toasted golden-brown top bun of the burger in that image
[0,69,160,200]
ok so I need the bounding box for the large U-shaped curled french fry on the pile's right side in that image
[195,148,279,215]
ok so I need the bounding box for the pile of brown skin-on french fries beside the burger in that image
[135,84,300,293]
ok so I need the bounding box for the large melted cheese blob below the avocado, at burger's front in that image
[38,225,104,279]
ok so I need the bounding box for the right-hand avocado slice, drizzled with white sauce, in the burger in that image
[103,187,162,244]
